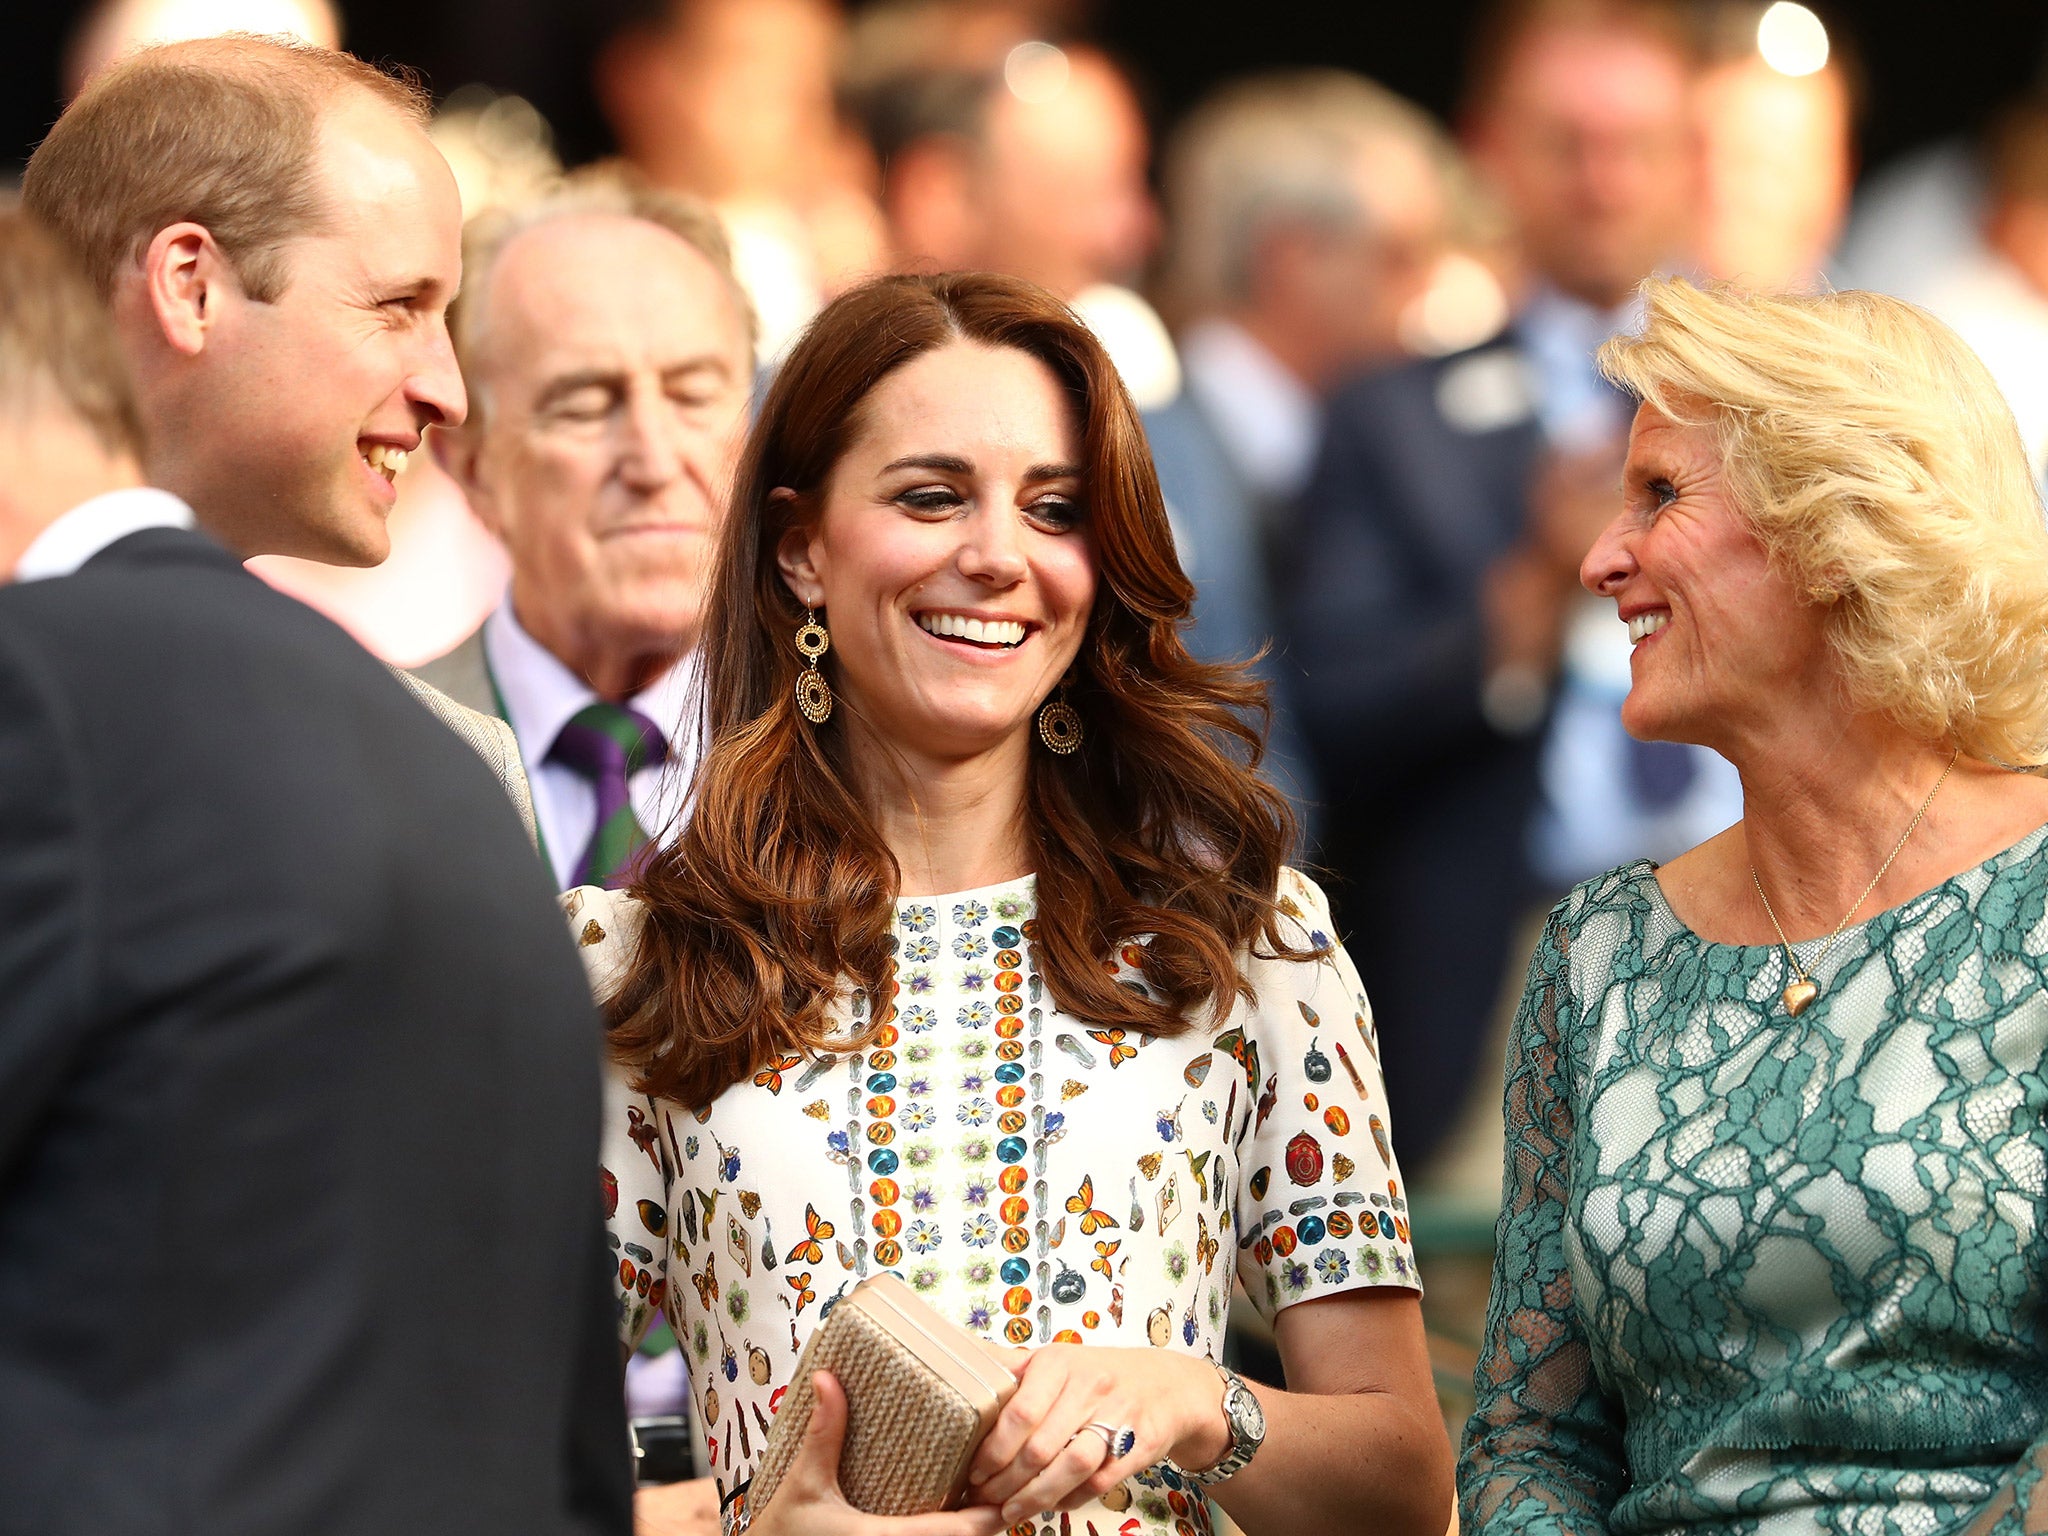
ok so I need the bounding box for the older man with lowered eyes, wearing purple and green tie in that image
[420,168,754,887]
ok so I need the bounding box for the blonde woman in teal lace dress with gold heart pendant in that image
[1460,281,2048,1532]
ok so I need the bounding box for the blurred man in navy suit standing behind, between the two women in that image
[1282,0,1733,1171]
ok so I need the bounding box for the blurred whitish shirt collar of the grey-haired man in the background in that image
[1180,315,1323,502]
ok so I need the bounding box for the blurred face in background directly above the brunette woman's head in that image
[958,51,1159,299]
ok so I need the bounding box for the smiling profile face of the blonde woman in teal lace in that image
[1579,406,1833,745]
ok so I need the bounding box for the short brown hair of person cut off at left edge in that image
[0,209,141,459]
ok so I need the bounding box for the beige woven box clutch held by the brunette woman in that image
[748,1274,1016,1516]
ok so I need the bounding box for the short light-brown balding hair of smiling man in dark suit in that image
[20,35,430,303]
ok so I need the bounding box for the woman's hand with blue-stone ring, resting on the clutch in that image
[967,1343,1231,1526]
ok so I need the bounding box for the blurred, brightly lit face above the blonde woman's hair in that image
[1694,59,1855,289]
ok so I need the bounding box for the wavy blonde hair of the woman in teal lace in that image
[1599,279,2048,768]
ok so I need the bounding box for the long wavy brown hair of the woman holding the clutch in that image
[610,272,1309,1108]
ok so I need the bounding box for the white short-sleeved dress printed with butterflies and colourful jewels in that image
[569,870,1419,1536]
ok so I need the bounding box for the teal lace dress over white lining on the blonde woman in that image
[1458,827,2048,1536]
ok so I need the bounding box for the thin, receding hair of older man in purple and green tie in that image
[449,160,758,426]
